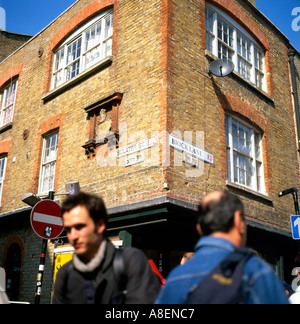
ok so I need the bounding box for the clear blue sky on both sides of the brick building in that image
[0,0,300,51]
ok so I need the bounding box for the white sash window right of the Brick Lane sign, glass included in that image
[225,116,265,194]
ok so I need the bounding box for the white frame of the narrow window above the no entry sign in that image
[38,130,59,194]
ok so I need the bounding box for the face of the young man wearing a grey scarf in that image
[63,206,106,262]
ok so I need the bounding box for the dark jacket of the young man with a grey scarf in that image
[53,242,160,304]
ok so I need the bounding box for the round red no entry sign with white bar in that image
[30,200,64,240]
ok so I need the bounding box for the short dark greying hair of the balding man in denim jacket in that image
[198,191,244,236]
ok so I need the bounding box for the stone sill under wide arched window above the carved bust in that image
[42,56,113,102]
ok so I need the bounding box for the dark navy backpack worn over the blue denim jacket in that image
[184,248,255,304]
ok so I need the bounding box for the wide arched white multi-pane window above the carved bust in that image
[51,10,113,90]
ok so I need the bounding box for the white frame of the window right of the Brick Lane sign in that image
[225,115,266,195]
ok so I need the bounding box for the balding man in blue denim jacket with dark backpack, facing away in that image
[156,191,288,304]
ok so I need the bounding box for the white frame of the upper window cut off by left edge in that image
[0,78,18,128]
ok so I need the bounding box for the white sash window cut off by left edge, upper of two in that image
[0,79,18,127]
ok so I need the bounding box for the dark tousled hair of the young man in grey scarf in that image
[61,192,108,225]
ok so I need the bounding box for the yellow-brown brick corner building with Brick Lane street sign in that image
[0,0,300,303]
